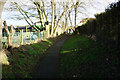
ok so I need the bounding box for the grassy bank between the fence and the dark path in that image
[2,35,63,78]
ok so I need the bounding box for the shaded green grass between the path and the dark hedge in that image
[60,35,120,78]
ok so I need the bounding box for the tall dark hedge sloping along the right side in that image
[75,1,120,48]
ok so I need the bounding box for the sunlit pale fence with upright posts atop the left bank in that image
[2,31,47,46]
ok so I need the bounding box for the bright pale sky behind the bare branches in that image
[2,0,118,26]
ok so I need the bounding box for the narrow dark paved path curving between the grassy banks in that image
[32,36,68,78]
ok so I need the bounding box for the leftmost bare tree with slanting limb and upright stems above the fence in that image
[12,0,49,31]
